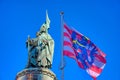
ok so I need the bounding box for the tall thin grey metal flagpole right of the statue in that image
[60,11,65,80]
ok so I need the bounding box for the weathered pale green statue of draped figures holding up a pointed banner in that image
[27,13,54,68]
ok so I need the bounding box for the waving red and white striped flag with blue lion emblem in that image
[63,24,106,80]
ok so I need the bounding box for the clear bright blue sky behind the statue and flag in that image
[0,0,120,80]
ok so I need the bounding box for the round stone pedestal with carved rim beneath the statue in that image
[16,68,57,80]
